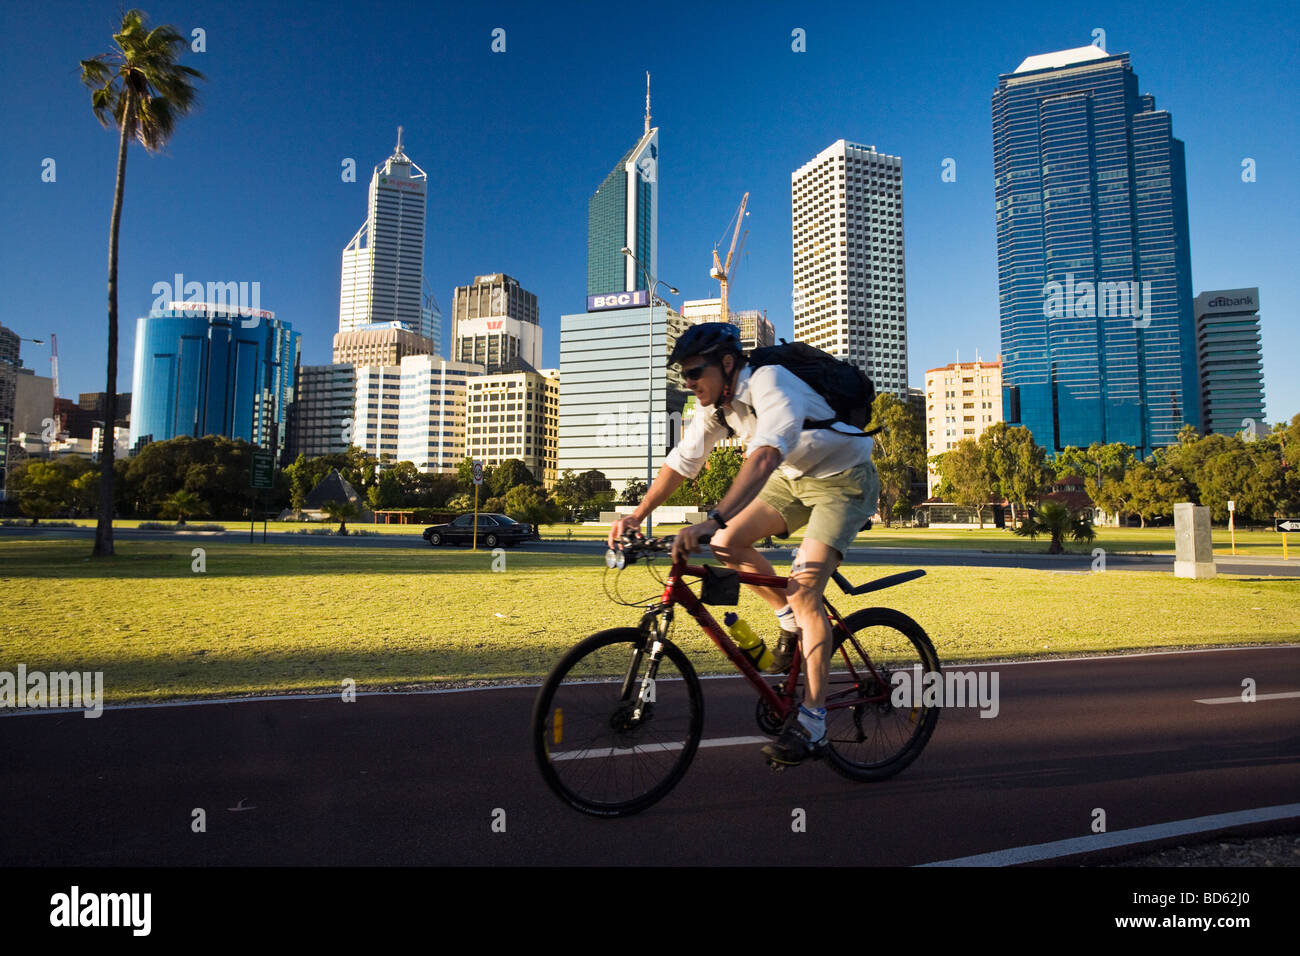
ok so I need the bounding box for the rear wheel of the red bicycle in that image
[826,607,940,782]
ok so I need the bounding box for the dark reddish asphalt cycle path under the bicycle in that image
[0,646,1300,866]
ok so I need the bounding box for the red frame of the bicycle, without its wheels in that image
[621,563,889,718]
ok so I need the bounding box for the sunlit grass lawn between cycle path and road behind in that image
[0,537,1300,702]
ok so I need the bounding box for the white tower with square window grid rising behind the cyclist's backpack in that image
[790,139,907,398]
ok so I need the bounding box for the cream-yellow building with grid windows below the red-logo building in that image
[465,368,560,488]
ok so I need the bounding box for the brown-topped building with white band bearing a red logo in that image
[451,273,542,373]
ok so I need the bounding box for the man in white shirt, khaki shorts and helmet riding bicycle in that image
[608,323,880,766]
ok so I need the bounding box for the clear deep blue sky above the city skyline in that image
[0,0,1300,421]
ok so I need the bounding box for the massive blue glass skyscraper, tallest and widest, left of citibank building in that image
[993,47,1201,454]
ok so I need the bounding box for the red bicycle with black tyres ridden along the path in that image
[532,535,940,817]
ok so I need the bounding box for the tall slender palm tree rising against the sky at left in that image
[81,10,203,557]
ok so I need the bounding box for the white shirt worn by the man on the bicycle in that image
[664,365,874,479]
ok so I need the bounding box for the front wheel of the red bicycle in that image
[532,627,705,817]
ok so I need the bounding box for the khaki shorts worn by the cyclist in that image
[758,460,880,558]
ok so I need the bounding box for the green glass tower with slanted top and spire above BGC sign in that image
[586,74,659,295]
